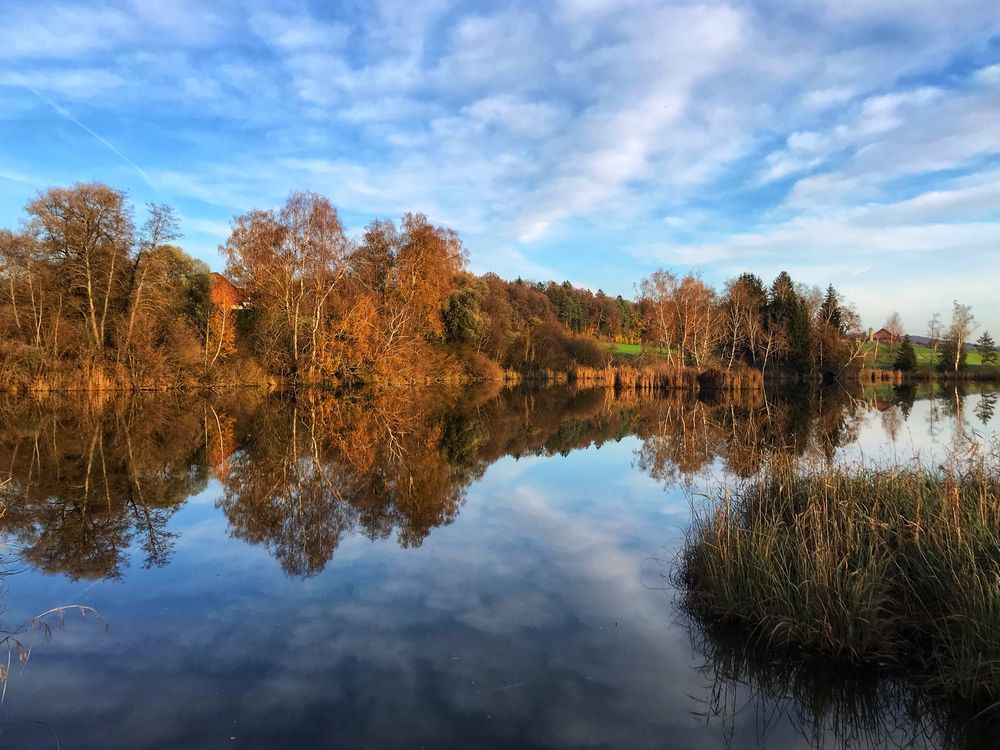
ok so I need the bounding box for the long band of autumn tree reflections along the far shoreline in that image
[0,388,980,579]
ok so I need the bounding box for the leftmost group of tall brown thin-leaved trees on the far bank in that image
[0,184,220,388]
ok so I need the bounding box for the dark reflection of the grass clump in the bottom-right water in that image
[687,611,1000,749]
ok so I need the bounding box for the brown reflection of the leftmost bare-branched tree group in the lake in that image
[0,400,208,579]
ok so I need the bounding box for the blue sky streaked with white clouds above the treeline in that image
[0,0,1000,334]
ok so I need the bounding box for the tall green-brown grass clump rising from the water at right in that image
[678,450,1000,702]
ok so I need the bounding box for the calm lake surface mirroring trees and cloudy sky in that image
[0,389,1000,748]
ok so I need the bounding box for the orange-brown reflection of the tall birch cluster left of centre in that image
[210,393,471,576]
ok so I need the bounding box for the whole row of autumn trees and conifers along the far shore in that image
[0,184,988,391]
